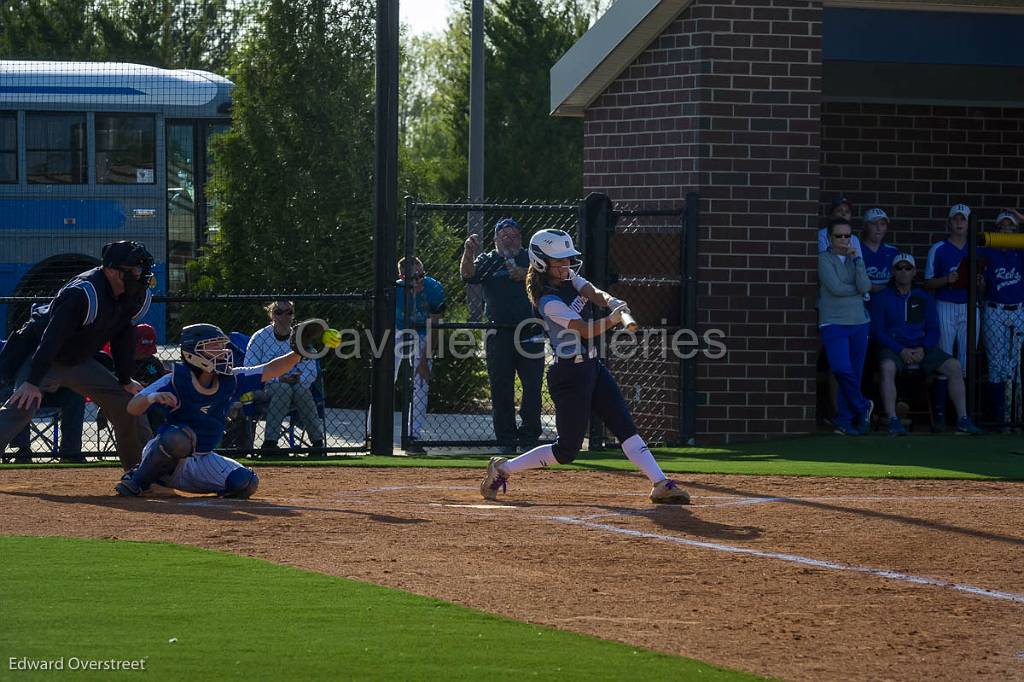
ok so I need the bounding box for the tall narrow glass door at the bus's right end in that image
[166,123,197,292]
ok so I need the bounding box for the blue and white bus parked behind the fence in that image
[0,60,233,338]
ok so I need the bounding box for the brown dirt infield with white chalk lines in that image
[0,467,1024,680]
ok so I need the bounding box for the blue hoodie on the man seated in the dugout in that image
[871,285,939,353]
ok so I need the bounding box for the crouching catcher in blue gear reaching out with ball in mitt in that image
[115,319,340,499]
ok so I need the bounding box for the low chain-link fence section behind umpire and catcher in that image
[0,292,373,461]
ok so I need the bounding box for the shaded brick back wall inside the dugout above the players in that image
[821,102,1024,260]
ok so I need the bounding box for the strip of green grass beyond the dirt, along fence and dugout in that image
[8,434,1024,480]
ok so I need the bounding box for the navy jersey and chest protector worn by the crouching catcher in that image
[139,363,263,455]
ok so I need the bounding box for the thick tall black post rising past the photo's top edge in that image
[370,0,398,455]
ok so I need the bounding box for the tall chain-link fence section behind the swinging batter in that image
[403,194,699,447]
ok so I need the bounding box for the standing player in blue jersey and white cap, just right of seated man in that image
[925,204,971,372]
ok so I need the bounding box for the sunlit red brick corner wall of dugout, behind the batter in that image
[584,0,821,442]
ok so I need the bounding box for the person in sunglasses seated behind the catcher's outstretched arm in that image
[246,300,325,453]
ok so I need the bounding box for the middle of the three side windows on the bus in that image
[25,113,89,184]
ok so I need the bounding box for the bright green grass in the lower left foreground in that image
[0,538,756,680]
